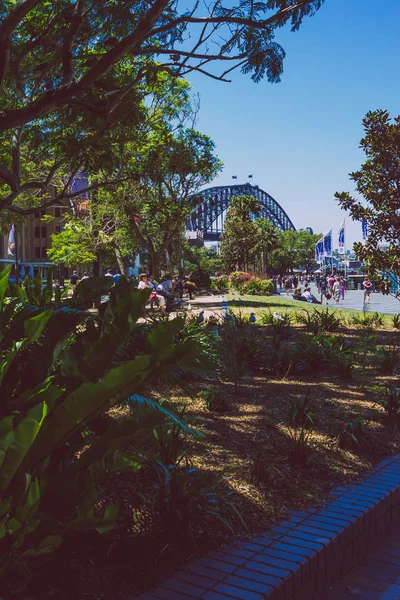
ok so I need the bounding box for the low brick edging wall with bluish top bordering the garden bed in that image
[138,456,400,600]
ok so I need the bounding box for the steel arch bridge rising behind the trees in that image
[187,183,296,239]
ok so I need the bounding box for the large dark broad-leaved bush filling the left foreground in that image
[0,270,206,575]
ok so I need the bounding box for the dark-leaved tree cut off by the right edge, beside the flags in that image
[335,110,400,298]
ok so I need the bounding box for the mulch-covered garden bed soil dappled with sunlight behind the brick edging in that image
[5,316,400,600]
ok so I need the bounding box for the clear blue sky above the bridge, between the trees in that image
[190,0,400,247]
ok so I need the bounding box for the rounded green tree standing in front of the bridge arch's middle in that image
[221,196,260,272]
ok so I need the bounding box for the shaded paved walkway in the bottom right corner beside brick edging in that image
[321,534,400,600]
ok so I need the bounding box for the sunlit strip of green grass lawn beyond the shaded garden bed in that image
[226,294,393,327]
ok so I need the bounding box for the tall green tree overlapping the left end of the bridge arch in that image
[124,128,222,278]
